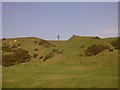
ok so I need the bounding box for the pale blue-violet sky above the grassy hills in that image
[2,2,118,40]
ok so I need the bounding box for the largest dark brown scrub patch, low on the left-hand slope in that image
[2,49,31,66]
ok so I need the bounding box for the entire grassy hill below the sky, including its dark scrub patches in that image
[2,36,120,88]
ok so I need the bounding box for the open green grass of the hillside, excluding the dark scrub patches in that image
[2,36,118,88]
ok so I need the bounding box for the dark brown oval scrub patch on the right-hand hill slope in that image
[85,45,110,56]
